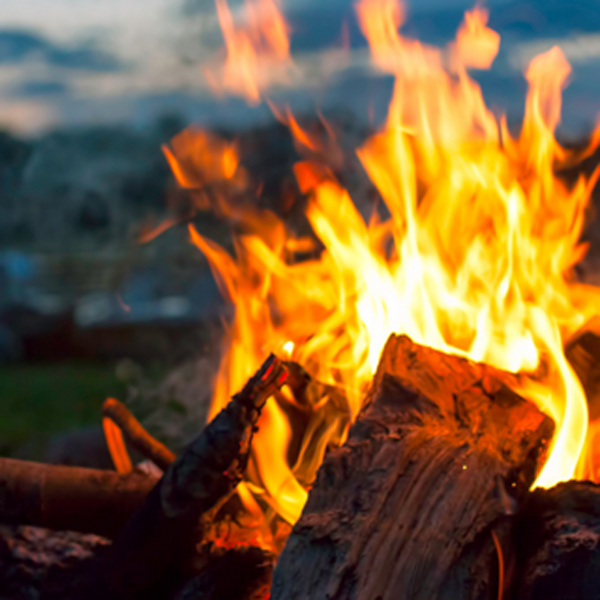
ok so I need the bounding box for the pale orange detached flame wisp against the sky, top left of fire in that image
[204,0,292,104]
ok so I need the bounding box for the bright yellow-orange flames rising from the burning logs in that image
[168,0,600,536]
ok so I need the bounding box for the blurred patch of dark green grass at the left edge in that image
[0,363,126,456]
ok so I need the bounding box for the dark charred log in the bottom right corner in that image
[514,481,600,600]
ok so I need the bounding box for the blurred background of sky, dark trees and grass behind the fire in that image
[0,0,600,466]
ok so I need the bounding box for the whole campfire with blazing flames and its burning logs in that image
[0,0,600,600]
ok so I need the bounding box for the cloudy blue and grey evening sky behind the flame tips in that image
[0,0,600,135]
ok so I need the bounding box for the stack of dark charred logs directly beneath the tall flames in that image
[0,336,600,600]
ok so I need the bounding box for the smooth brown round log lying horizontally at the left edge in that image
[0,458,158,538]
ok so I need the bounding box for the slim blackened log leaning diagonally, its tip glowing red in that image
[72,355,287,600]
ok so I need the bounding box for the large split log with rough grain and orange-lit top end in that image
[271,336,553,600]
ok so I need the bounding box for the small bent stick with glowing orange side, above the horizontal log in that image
[102,398,177,472]
